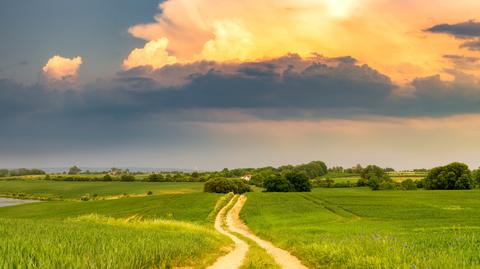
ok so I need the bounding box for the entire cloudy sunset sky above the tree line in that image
[0,0,480,170]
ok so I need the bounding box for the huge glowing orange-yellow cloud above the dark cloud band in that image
[127,0,480,83]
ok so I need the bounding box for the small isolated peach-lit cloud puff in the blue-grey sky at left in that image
[42,55,83,81]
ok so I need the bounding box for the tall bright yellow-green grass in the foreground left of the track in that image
[0,215,225,268]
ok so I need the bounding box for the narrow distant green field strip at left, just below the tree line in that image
[0,180,203,199]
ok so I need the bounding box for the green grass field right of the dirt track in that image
[241,188,480,268]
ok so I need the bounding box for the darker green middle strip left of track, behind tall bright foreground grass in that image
[0,193,221,225]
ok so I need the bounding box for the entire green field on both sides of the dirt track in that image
[0,177,480,269]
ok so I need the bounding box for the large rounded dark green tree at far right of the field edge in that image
[424,163,474,190]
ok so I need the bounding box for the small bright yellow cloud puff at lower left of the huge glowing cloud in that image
[123,38,177,69]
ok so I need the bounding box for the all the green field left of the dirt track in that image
[0,181,229,268]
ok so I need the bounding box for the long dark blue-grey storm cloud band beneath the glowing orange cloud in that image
[0,52,480,150]
